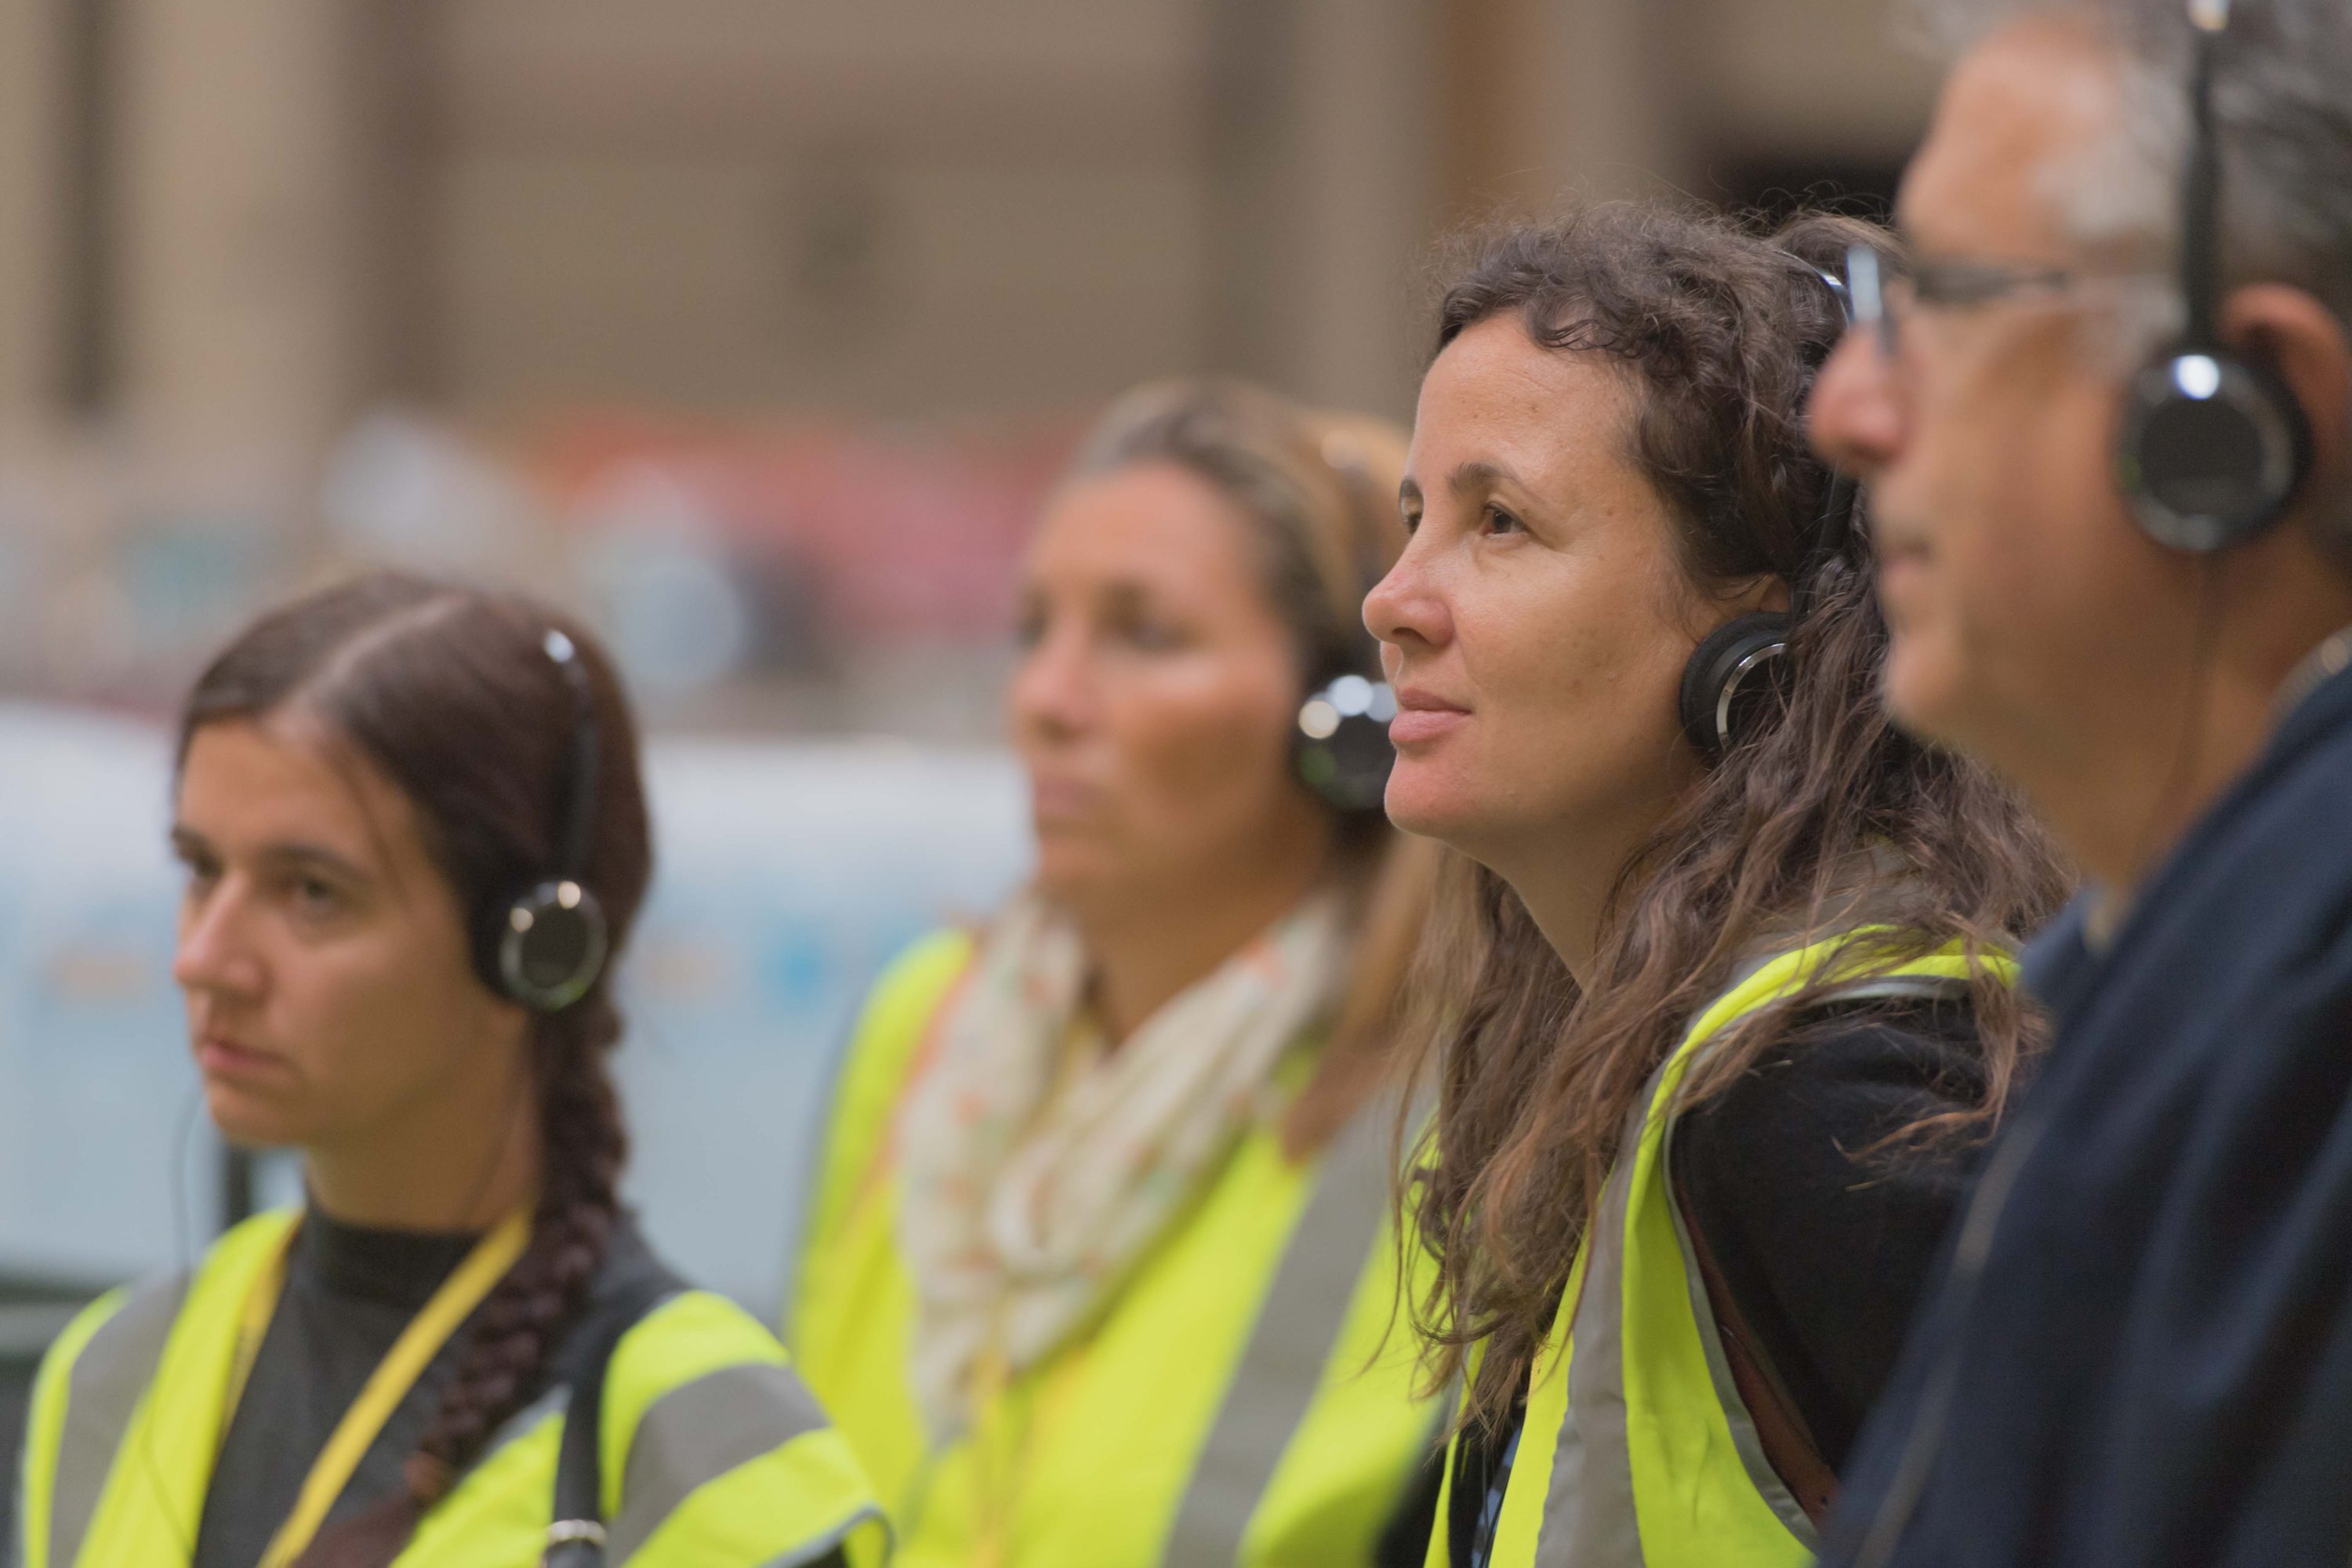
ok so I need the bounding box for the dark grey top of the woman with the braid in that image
[193,1208,682,1568]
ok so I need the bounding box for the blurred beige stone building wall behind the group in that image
[0,0,1931,728]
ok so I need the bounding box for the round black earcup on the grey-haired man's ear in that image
[2114,350,2312,555]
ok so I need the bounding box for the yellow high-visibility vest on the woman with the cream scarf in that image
[786,933,1437,1568]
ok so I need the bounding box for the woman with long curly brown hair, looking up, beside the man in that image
[1367,205,2063,1568]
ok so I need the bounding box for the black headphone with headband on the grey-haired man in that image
[2114,0,2312,553]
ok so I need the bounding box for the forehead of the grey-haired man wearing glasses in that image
[1898,16,2122,261]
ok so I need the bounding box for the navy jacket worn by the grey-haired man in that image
[1823,673,2352,1568]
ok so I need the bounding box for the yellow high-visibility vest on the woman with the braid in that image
[24,1213,884,1568]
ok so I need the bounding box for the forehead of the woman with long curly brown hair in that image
[1406,313,1628,492]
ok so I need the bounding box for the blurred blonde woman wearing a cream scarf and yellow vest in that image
[788,383,1435,1568]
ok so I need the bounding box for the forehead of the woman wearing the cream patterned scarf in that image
[1028,461,1258,602]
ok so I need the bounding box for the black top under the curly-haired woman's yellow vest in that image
[1446,1001,1983,1568]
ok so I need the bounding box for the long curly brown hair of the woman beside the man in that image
[1399,202,2067,1422]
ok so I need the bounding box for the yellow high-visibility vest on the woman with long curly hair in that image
[1468,938,2013,1568]
